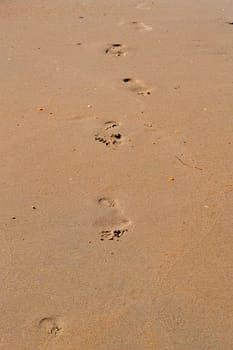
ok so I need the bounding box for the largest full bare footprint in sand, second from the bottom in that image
[95,197,130,241]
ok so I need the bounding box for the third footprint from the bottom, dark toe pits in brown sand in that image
[95,121,122,146]
